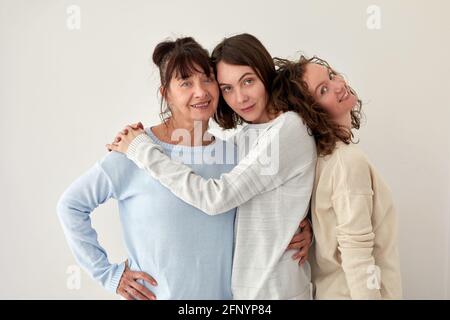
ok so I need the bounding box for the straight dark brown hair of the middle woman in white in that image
[211,33,276,129]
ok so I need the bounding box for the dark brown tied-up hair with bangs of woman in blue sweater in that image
[153,37,213,122]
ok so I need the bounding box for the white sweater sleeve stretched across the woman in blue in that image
[127,115,316,215]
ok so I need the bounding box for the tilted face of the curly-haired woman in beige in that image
[303,63,357,121]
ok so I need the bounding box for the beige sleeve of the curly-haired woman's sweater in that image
[332,151,381,299]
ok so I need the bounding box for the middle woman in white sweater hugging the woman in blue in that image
[108,34,317,299]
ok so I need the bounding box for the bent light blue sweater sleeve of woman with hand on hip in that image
[57,164,125,293]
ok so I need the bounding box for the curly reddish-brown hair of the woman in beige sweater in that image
[272,56,362,156]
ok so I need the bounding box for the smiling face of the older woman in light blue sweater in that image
[166,66,219,122]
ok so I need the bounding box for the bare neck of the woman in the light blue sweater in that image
[162,117,214,147]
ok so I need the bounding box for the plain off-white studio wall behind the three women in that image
[0,0,450,299]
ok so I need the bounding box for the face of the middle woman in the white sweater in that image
[217,62,269,123]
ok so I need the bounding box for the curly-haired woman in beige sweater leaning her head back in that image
[274,56,402,299]
